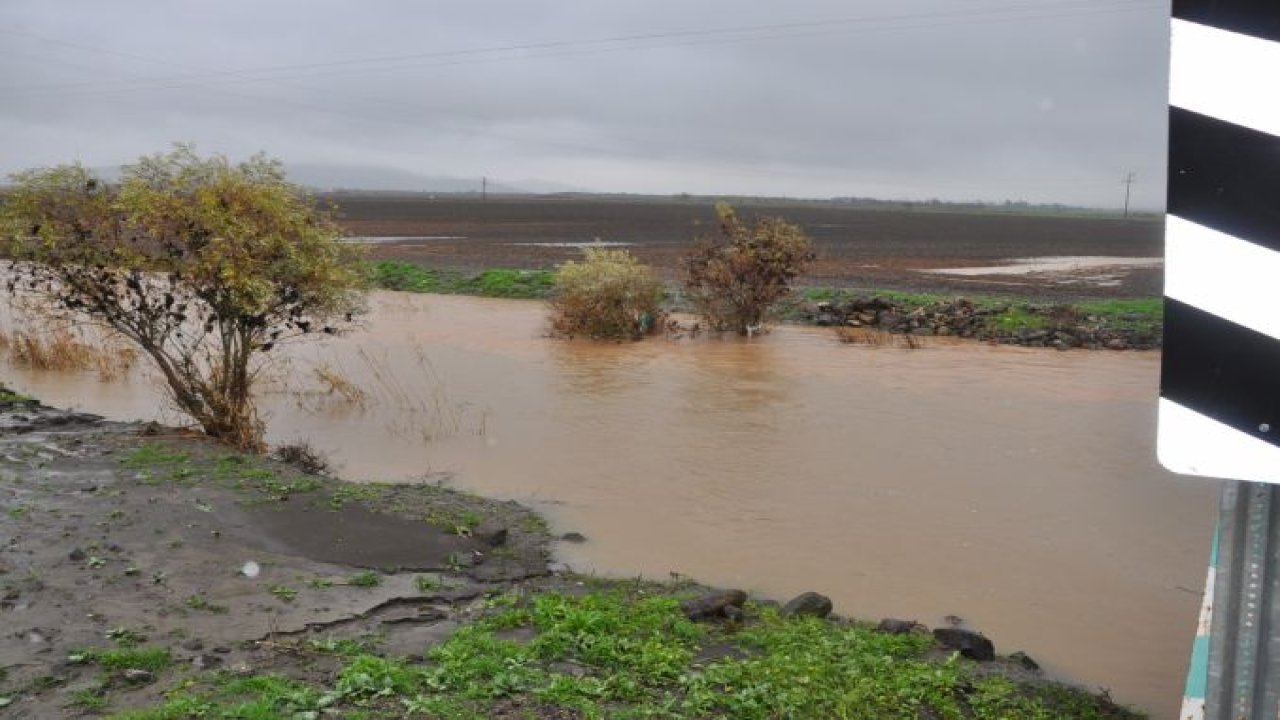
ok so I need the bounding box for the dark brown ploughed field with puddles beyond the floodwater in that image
[326,195,1164,300]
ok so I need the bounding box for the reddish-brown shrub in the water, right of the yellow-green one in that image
[684,202,814,334]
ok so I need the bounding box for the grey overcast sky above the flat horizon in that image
[0,0,1167,208]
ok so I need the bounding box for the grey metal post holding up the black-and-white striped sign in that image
[1204,480,1280,720]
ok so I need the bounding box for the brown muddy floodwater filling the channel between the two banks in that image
[0,293,1216,716]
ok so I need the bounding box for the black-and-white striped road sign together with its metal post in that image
[1157,0,1280,720]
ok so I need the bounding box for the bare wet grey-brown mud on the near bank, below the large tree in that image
[0,394,548,719]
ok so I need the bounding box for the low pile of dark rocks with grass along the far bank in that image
[800,296,1161,350]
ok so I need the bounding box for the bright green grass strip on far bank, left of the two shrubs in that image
[370,260,554,299]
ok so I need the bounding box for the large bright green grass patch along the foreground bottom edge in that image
[102,589,1138,720]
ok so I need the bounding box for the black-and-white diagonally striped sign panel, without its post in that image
[1157,0,1280,483]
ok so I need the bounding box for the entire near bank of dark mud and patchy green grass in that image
[0,392,1134,719]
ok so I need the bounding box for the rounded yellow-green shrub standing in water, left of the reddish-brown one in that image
[550,247,662,340]
